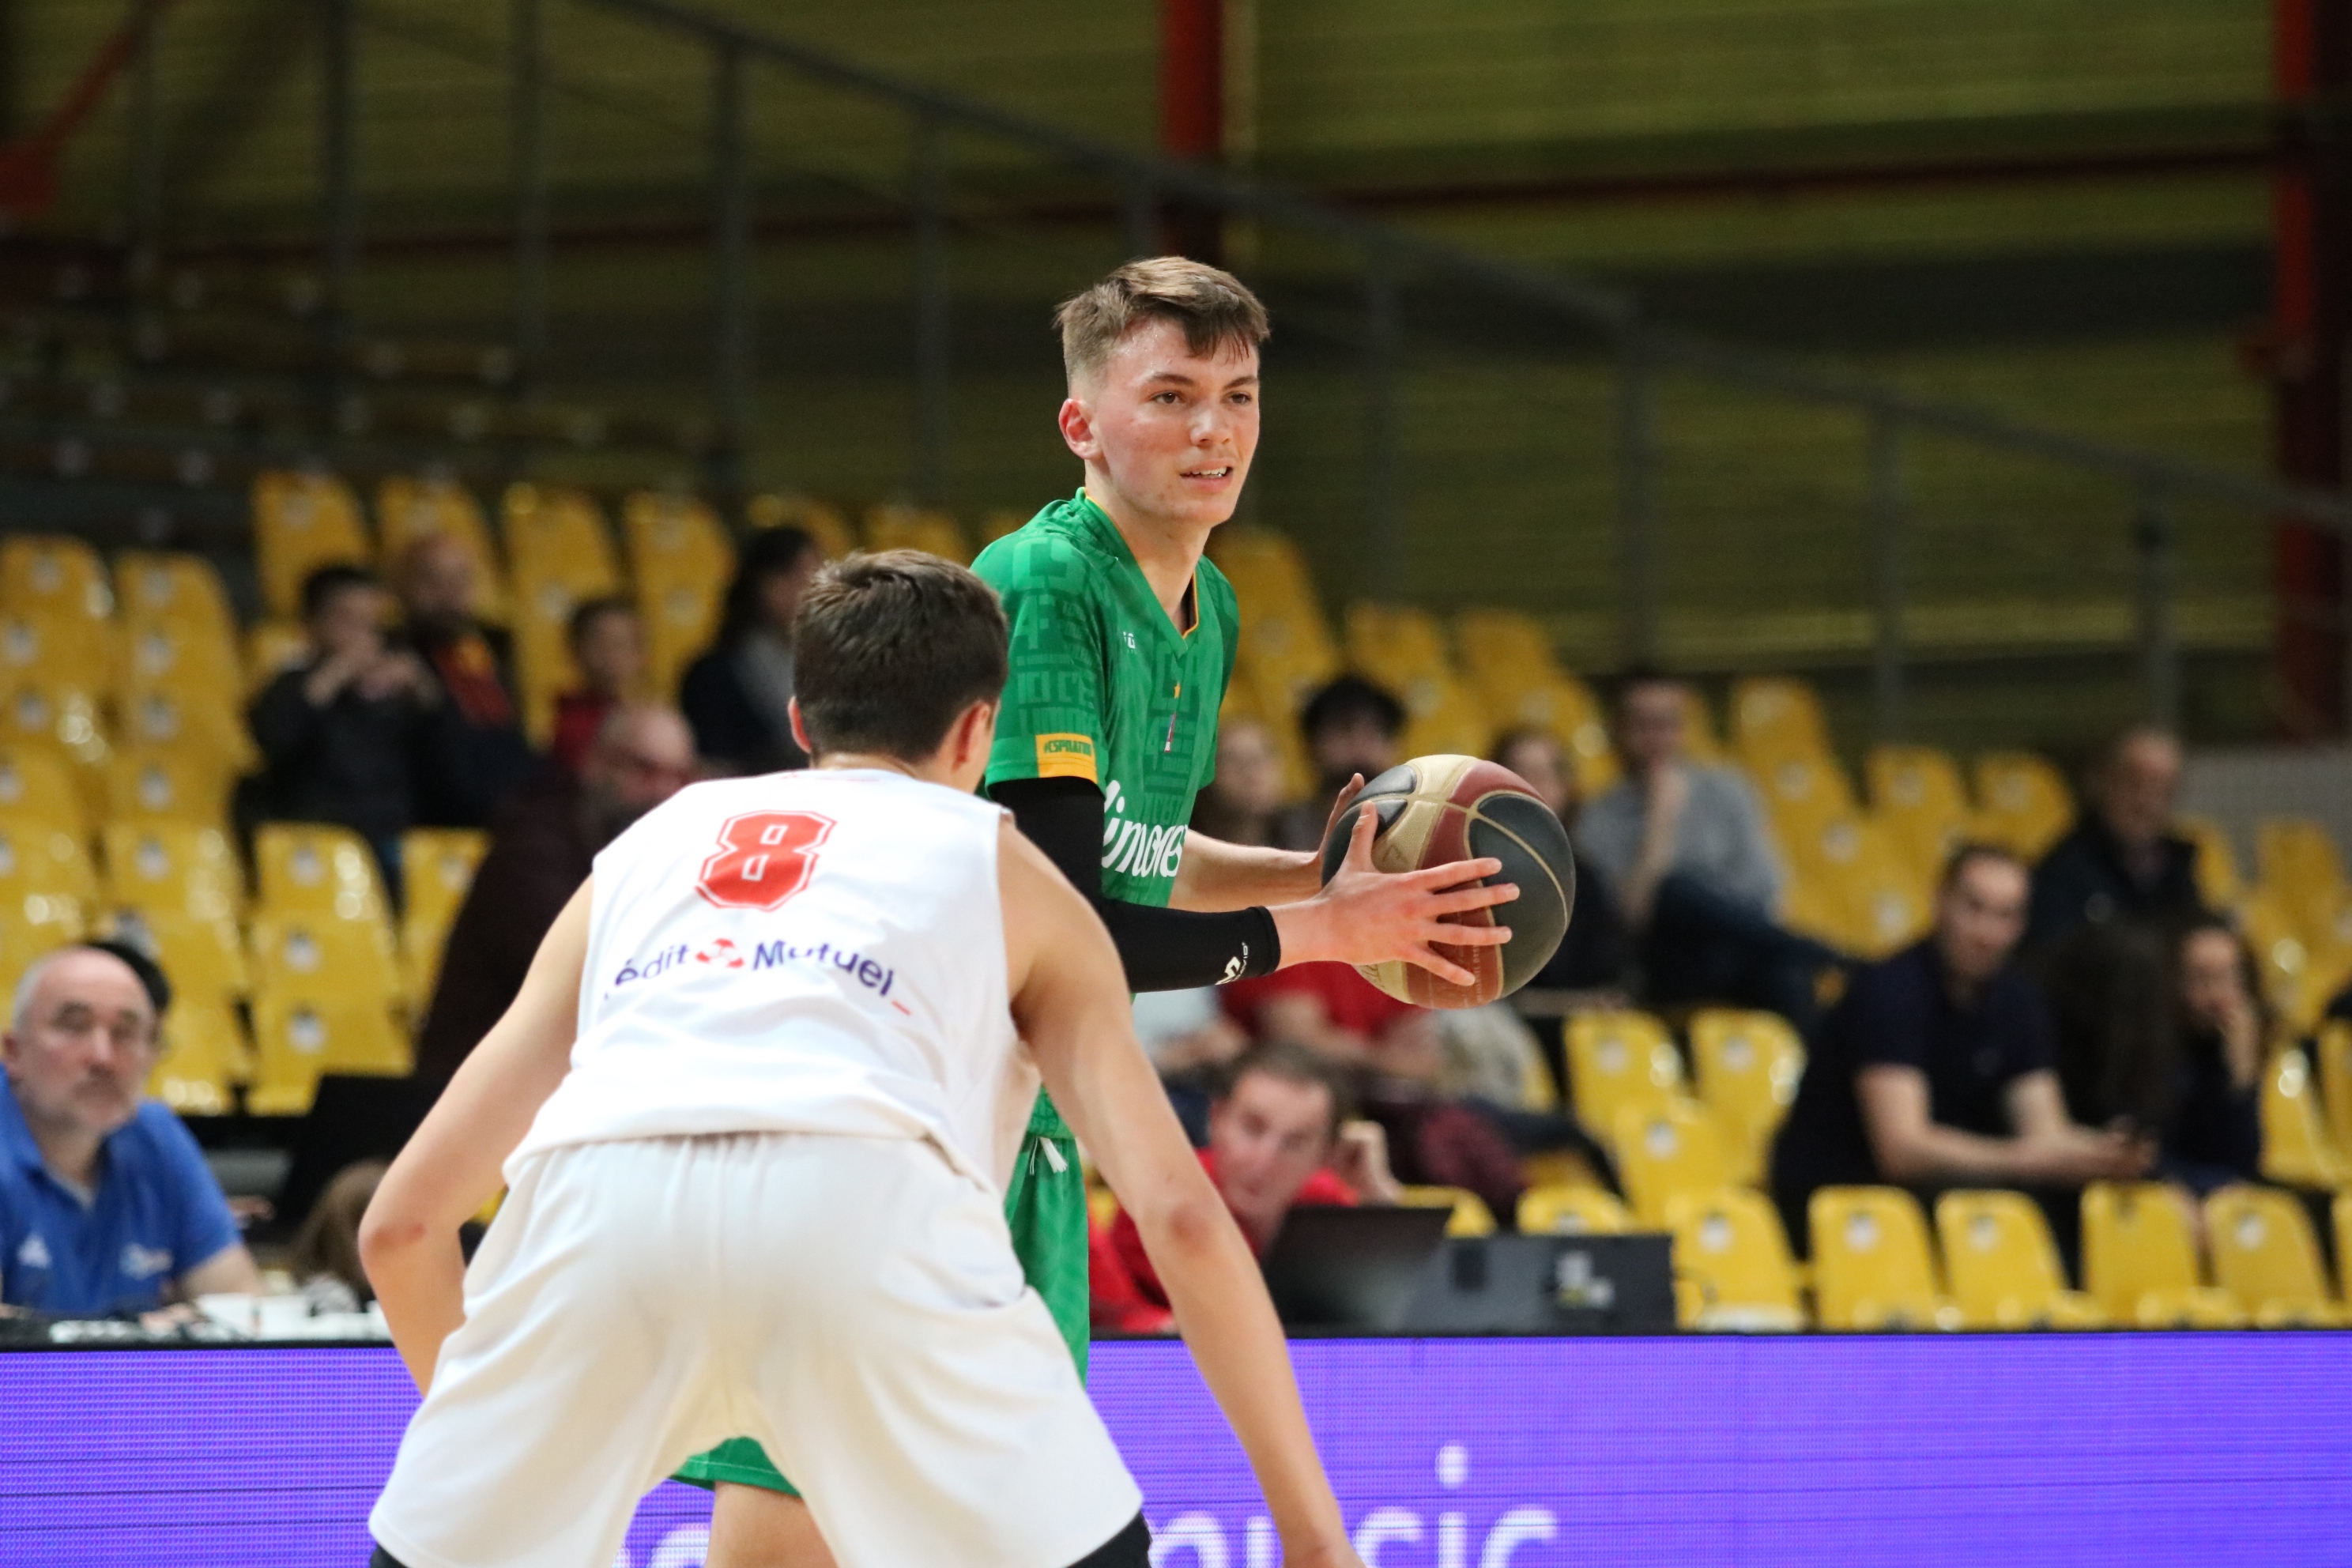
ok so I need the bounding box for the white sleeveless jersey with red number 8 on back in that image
[511,769,1037,1187]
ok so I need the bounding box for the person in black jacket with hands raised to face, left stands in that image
[247,567,456,888]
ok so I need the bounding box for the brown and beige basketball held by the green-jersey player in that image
[1322,757,1576,1008]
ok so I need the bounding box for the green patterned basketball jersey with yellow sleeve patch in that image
[971,492,1242,905]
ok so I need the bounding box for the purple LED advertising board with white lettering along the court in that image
[0,1333,2352,1568]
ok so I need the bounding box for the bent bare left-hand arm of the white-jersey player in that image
[360,881,590,1392]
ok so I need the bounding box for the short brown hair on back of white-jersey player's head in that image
[793,550,1007,762]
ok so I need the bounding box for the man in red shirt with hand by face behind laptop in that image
[1094,1044,1402,1333]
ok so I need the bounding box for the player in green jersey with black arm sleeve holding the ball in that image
[680,256,1517,1568]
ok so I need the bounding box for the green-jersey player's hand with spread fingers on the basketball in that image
[1282,811,1519,985]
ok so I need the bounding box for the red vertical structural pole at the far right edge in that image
[2270,0,2352,738]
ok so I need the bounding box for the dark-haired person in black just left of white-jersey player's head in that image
[677,529,826,774]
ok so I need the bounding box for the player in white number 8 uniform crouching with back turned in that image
[360,552,1498,1568]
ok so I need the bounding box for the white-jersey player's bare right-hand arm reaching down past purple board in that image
[997,825,1359,1568]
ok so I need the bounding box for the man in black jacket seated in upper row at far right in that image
[2025,724,2204,950]
